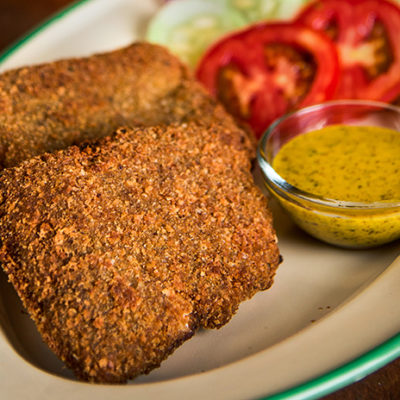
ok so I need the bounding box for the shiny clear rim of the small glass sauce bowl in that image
[257,100,400,212]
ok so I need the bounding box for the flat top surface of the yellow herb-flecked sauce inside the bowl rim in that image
[273,125,400,202]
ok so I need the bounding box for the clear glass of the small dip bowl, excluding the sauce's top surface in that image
[257,100,400,248]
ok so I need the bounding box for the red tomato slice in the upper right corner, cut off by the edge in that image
[297,0,400,101]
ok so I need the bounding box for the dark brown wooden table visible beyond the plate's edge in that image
[0,0,400,400]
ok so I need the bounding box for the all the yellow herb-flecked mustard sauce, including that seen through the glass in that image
[272,125,400,247]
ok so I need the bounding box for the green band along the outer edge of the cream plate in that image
[0,0,400,400]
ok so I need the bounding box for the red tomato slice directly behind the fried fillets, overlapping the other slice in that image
[196,23,339,137]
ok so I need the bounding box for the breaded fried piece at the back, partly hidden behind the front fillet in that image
[0,43,252,168]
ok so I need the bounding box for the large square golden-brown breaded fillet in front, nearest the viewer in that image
[0,123,280,383]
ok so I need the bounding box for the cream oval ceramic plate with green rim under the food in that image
[0,0,400,400]
